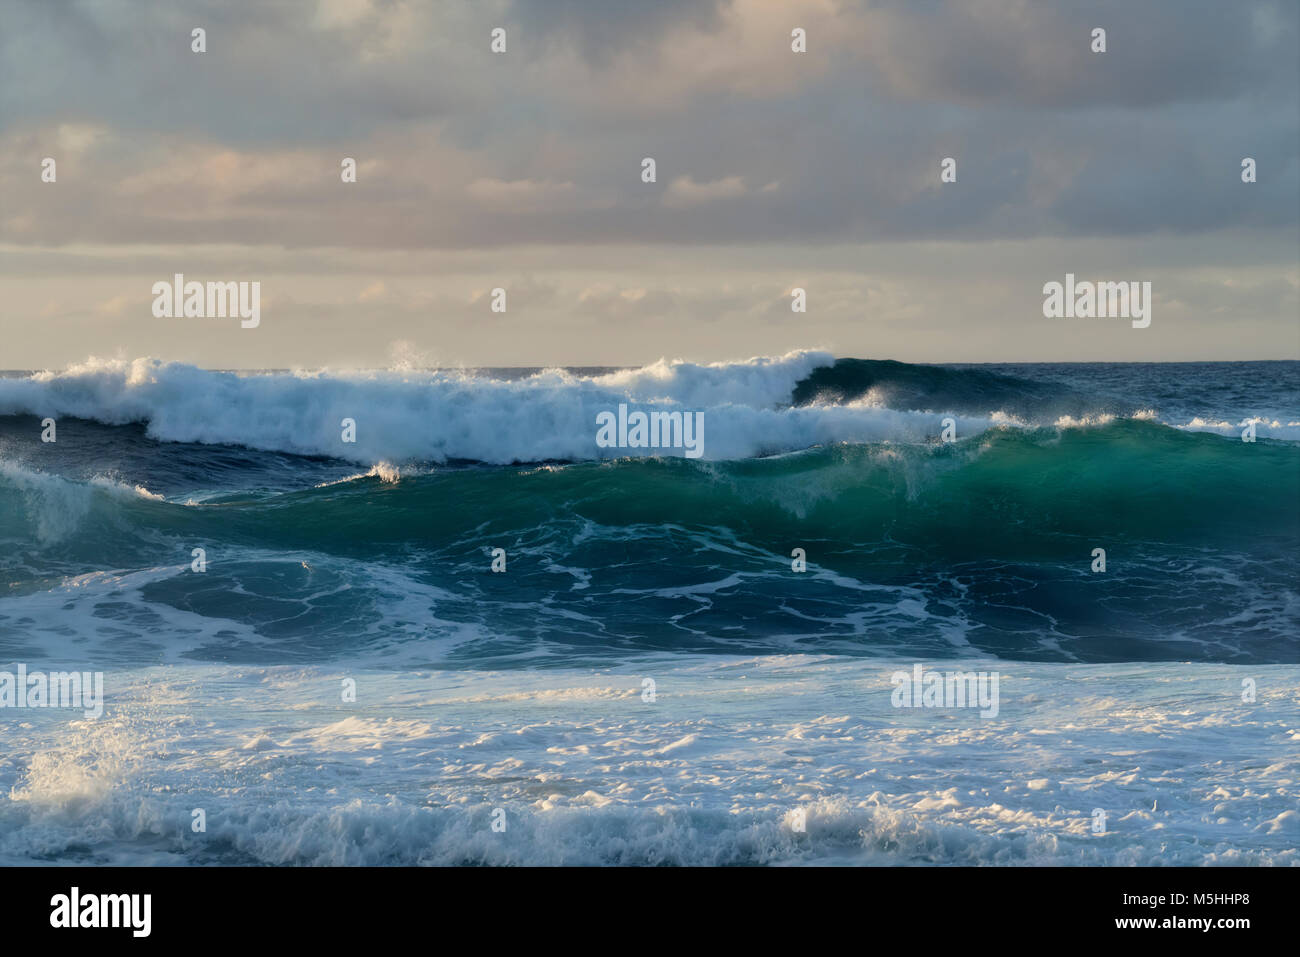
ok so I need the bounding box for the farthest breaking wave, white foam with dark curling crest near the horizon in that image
[0,351,1300,467]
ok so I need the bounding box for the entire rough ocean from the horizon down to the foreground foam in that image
[0,351,1300,865]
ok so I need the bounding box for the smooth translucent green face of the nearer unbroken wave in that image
[0,420,1300,558]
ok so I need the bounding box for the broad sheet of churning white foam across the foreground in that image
[0,655,1300,865]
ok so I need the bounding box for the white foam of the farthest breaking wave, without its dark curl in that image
[0,352,873,468]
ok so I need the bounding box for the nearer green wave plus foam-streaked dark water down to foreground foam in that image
[0,420,1300,667]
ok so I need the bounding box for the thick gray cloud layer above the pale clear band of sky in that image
[0,0,1300,247]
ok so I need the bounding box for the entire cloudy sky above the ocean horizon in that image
[0,0,1300,368]
